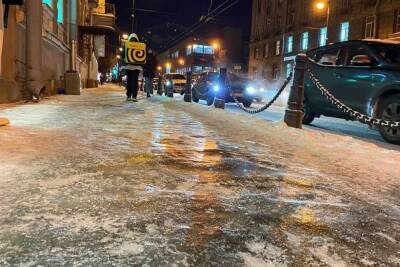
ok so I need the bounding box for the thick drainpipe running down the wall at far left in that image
[25,1,43,99]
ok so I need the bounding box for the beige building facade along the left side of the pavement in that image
[0,0,115,103]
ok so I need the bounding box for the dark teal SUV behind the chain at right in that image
[303,40,400,144]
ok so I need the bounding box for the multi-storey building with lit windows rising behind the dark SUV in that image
[249,0,400,80]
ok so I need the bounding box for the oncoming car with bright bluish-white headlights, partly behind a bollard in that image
[192,72,257,107]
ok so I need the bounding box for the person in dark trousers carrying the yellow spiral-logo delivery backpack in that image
[122,33,143,102]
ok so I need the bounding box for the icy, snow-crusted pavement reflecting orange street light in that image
[0,87,400,266]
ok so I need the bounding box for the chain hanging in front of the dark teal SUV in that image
[307,68,400,128]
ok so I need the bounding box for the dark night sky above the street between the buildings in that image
[109,0,252,49]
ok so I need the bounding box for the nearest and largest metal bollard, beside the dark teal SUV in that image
[284,54,307,129]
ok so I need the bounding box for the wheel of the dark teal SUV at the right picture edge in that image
[378,94,400,145]
